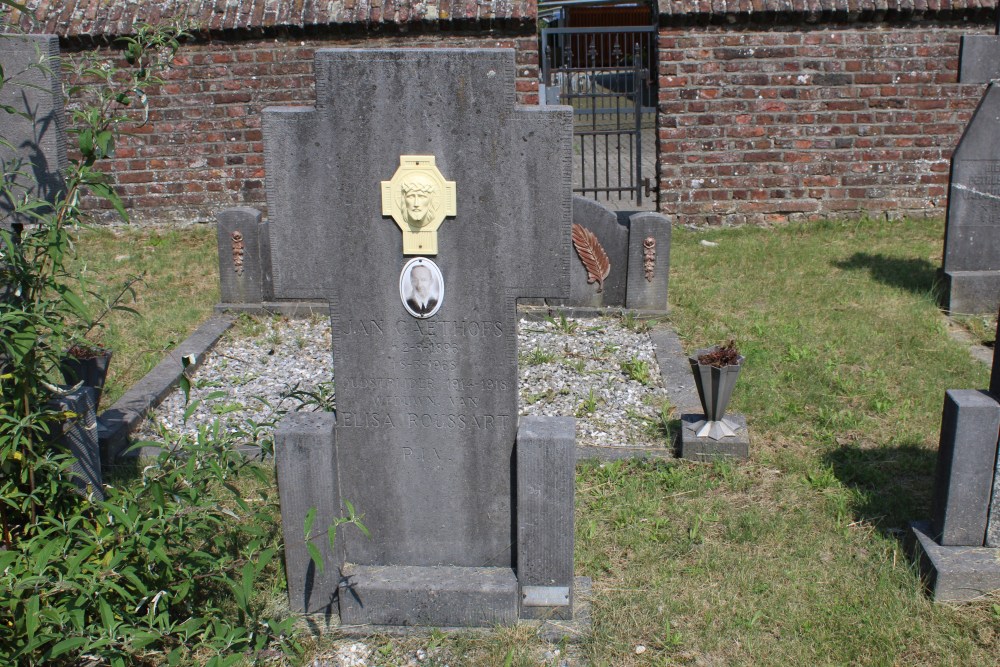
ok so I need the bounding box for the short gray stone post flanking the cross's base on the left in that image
[274,412,342,613]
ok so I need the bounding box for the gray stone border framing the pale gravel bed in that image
[98,301,701,466]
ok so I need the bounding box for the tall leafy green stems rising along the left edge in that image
[0,24,184,549]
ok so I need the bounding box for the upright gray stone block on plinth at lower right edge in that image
[931,389,1000,547]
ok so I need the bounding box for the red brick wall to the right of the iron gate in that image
[658,17,993,224]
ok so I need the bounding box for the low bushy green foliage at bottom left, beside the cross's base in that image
[0,423,297,665]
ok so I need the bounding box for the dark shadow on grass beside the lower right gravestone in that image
[823,443,937,537]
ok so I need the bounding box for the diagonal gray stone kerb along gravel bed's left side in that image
[98,315,234,463]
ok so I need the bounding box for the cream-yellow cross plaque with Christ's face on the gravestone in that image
[382,155,458,255]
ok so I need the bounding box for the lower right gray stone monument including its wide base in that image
[911,316,1000,602]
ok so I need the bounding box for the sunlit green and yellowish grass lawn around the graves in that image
[72,220,1000,666]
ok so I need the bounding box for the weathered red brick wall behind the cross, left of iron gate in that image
[64,33,538,223]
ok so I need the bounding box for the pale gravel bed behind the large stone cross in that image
[138,317,669,447]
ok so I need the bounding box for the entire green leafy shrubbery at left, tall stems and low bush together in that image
[0,20,306,667]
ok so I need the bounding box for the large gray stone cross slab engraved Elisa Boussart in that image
[263,49,571,567]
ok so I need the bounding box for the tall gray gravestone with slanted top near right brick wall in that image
[943,83,1000,313]
